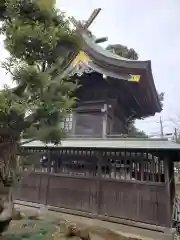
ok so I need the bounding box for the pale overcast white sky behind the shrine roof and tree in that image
[0,0,180,135]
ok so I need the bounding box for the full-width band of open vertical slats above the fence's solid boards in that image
[22,149,165,183]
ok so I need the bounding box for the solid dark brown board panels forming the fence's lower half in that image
[17,173,169,227]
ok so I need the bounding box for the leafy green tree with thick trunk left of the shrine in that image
[0,0,81,229]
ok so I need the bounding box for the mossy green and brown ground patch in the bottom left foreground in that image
[4,207,128,240]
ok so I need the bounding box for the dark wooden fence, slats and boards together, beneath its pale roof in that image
[17,147,170,227]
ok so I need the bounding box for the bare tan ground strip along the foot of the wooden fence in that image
[16,203,174,240]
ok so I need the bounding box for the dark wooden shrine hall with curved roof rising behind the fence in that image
[52,12,161,138]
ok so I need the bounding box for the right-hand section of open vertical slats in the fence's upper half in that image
[102,152,164,182]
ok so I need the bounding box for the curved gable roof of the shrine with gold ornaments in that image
[57,25,162,117]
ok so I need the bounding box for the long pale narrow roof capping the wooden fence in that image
[22,138,180,152]
